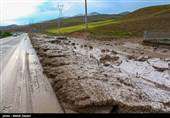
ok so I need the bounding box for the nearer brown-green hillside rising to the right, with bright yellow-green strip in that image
[46,5,170,39]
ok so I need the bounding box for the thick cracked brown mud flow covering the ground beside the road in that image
[32,34,170,113]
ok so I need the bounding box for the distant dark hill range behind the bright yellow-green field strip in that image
[11,12,125,32]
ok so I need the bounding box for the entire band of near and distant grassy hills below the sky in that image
[7,5,170,40]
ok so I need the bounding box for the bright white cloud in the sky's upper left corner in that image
[0,0,46,25]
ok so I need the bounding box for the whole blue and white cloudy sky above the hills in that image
[0,0,170,26]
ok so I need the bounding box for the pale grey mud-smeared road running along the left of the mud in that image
[0,33,63,113]
